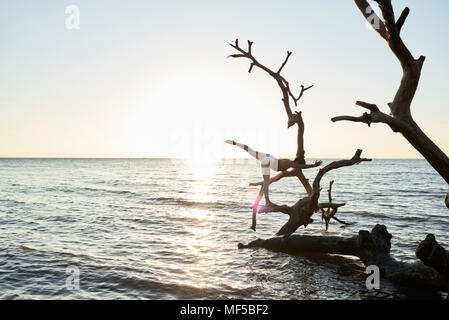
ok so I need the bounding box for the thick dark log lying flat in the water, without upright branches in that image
[238,225,449,290]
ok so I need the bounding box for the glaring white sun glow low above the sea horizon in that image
[121,70,261,160]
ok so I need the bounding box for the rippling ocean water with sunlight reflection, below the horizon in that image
[0,159,449,299]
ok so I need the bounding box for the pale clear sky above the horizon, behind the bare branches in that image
[0,0,449,158]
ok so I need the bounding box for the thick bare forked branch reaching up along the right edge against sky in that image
[332,0,449,189]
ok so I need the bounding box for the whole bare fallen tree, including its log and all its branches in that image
[230,0,449,296]
